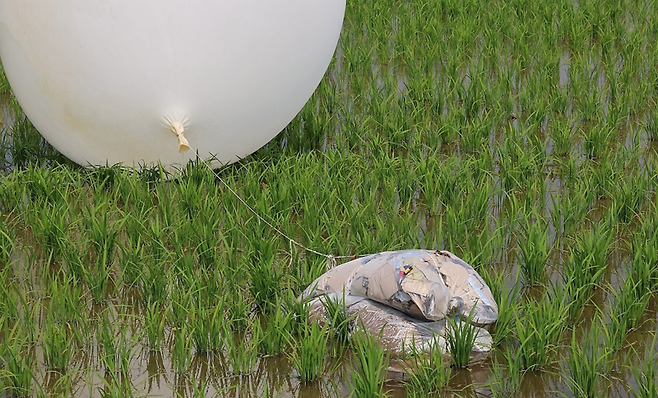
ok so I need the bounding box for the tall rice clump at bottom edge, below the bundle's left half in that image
[350,328,389,398]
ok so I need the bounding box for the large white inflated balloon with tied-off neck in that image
[0,0,345,166]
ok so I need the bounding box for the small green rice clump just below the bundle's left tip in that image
[290,322,329,383]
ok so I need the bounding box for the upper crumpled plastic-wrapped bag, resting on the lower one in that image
[302,250,498,325]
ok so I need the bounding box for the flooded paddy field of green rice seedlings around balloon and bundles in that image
[0,0,658,397]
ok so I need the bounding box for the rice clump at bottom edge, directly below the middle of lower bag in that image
[404,337,450,397]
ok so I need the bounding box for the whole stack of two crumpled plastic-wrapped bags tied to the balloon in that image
[300,250,498,354]
